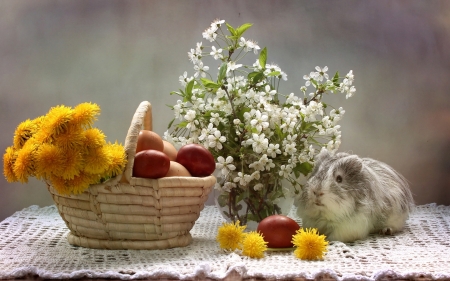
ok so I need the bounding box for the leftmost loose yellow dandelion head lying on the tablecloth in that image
[216,221,246,251]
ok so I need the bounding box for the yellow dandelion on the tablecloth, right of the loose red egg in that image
[292,228,328,260]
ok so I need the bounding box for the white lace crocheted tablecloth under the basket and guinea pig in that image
[0,204,450,280]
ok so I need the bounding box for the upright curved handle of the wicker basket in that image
[120,101,153,183]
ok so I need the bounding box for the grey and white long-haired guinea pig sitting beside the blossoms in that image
[296,150,414,242]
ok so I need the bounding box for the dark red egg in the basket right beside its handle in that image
[133,149,170,179]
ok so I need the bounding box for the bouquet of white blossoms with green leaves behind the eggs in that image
[165,20,355,225]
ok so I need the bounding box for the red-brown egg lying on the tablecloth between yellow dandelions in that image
[257,215,300,248]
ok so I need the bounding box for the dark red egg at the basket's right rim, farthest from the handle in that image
[176,143,216,177]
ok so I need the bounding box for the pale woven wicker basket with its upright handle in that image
[48,101,216,250]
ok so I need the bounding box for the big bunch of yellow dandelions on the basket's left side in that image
[3,103,126,194]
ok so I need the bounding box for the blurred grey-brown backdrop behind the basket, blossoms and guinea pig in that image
[0,0,450,221]
